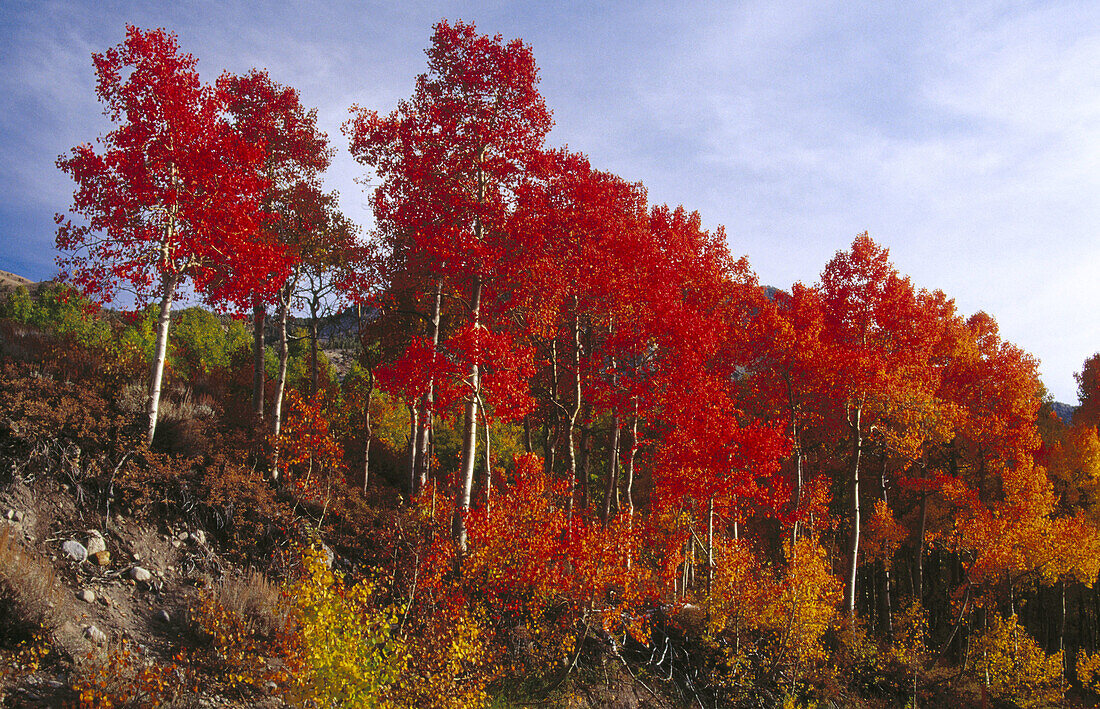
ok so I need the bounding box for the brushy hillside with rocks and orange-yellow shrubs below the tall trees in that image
[0,272,1096,709]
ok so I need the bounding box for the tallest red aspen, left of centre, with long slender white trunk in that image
[344,21,550,550]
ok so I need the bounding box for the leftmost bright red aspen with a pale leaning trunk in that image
[57,26,287,444]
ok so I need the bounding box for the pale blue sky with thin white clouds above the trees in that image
[0,0,1100,403]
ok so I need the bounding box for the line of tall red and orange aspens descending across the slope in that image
[57,21,1100,701]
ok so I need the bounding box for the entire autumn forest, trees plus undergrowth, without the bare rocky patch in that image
[0,21,1100,708]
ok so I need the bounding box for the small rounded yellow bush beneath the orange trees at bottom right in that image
[970,616,1065,709]
